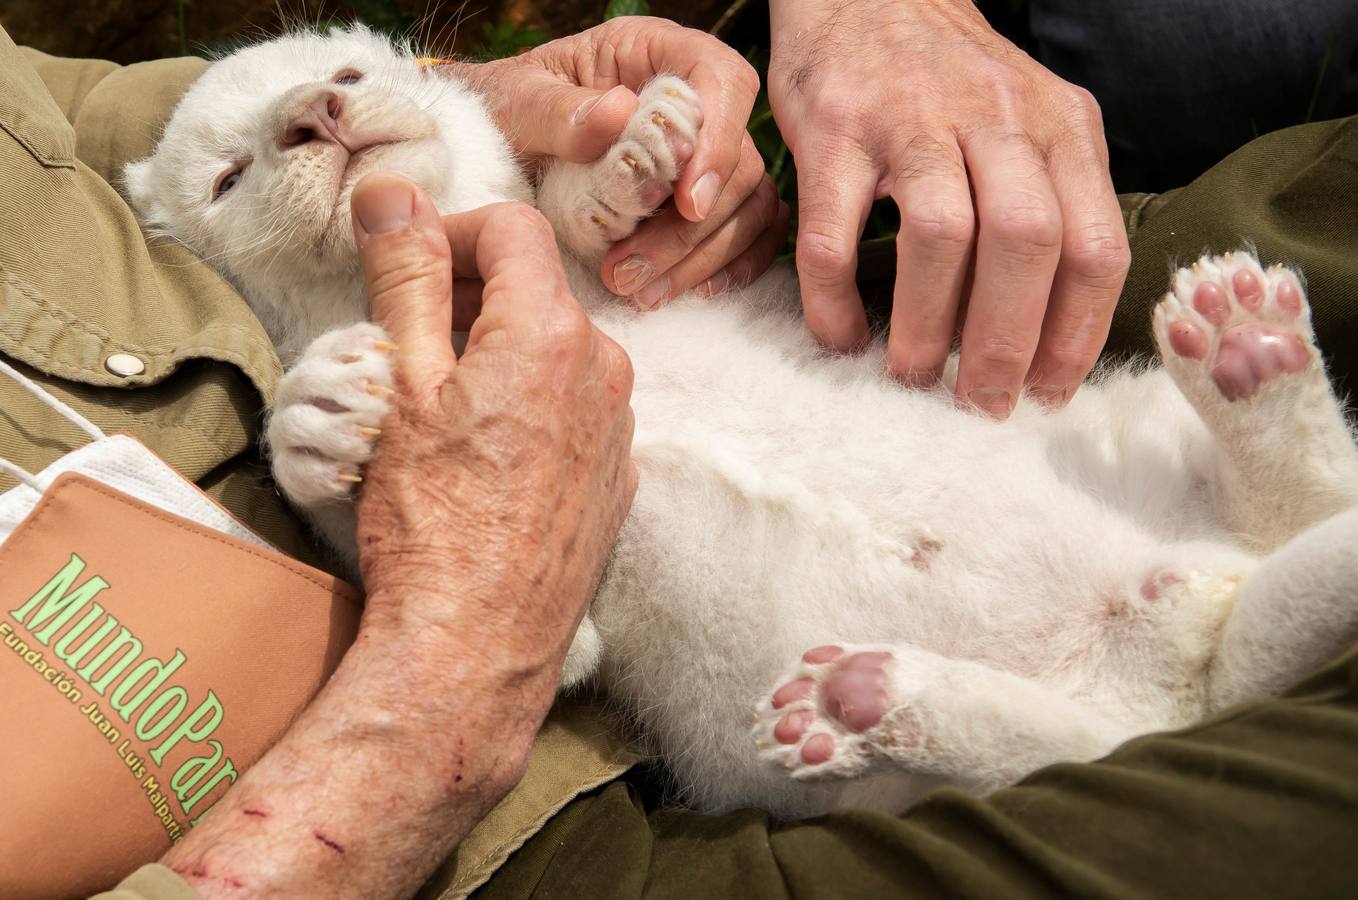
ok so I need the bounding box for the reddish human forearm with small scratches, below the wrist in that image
[154,597,551,897]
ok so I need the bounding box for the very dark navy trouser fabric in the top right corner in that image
[1028,0,1358,190]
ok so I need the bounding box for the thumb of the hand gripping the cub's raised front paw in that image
[497,71,638,163]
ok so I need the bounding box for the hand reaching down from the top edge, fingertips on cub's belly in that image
[769,0,1130,418]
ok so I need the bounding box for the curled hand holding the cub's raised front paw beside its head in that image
[458,16,789,306]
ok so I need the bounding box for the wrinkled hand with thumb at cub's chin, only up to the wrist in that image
[353,175,637,692]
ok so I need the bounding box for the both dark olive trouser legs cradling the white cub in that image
[478,119,1358,900]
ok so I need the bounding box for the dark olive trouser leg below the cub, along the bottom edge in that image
[477,654,1358,900]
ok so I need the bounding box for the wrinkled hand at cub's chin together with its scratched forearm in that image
[162,174,637,899]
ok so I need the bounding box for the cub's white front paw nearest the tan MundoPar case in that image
[268,322,395,509]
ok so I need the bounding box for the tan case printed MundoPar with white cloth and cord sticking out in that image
[0,362,360,899]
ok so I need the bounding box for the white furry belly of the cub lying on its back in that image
[578,282,1238,813]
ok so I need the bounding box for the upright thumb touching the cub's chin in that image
[350,172,458,395]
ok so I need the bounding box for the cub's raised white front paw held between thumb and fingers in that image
[539,75,702,258]
